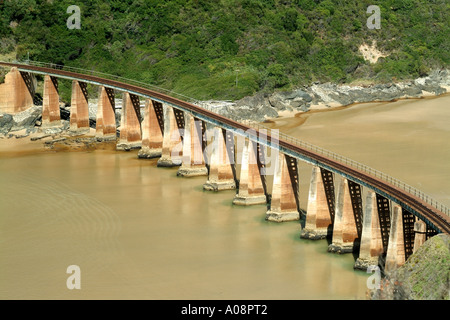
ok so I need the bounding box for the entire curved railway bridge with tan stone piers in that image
[0,61,450,271]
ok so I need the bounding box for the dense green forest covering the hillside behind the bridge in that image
[0,0,450,100]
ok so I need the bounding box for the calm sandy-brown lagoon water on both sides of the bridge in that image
[0,96,450,300]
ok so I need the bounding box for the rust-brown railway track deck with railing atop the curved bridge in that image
[0,62,450,234]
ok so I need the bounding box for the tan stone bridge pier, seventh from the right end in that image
[233,140,267,206]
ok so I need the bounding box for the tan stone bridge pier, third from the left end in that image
[70,80,90,133]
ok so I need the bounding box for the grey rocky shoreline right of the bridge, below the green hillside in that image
[198,69,450,122]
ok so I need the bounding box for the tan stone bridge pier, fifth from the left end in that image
[116,92,142,151]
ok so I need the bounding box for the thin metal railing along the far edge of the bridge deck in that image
[14,60,450,216]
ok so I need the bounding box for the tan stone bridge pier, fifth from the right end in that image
[300,166,334,240]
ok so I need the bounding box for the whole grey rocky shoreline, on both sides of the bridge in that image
[0,69,450,138]
